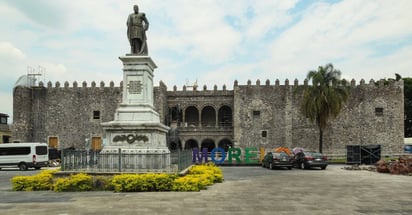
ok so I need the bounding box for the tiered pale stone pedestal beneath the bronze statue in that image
[98,55,171,172]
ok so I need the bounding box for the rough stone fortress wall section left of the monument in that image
[12,82,122,148]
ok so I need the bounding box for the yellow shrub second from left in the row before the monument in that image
[53,173,93,192]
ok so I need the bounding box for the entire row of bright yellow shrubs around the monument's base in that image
[11,164,223,192]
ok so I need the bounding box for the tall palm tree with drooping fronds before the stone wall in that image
[301,63,349,153]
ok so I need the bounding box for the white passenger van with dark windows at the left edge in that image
[0,143,49,170]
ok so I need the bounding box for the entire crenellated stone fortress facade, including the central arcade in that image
[12,80,404,154]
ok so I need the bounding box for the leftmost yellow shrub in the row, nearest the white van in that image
[11,170,58,191]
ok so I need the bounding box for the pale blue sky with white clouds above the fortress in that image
[0,0,412,121]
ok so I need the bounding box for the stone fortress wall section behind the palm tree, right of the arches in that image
[234,80,404,154]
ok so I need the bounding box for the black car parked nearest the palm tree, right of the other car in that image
[292,151,328,169]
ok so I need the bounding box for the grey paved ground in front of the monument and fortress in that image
[0,165,412,215]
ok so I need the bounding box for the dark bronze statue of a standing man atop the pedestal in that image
[127,5,149,55]
